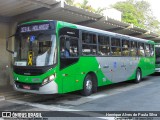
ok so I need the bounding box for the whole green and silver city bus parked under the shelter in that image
[6,20,155,96]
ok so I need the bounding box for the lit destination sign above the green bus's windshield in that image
[20,23,50,33]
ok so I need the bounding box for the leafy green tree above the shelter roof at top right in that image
[112,0,160,32]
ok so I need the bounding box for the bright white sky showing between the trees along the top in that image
[75,0,160,21]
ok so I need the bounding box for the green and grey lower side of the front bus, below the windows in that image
[59,56,155,93]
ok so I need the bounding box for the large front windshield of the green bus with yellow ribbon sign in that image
[14,32,57,66]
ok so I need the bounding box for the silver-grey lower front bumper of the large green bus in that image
[14,81,58,94]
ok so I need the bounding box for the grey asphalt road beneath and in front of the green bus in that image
[0,74,160,120]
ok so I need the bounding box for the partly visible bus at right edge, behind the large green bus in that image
[155,43,160,72]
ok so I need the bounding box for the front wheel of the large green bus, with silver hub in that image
[82,74,93,96]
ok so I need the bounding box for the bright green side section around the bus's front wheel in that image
[58,57,112,93]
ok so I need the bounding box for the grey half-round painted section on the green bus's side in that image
[97,56,139,83]
